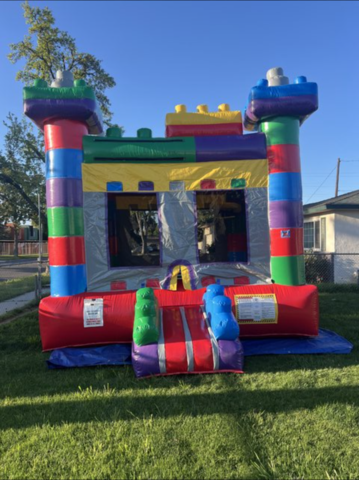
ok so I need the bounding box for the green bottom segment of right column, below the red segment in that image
[271,255,305,285]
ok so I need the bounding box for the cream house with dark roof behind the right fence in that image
[304,190,359,283]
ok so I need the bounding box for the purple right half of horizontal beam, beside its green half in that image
[195,133,267,162]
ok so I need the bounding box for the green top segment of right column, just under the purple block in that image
[259,117,299,147]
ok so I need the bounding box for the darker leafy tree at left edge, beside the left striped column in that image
[0,113,47,234]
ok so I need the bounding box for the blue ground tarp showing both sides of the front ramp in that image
[47,329,353,368]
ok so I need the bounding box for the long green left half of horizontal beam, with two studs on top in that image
[83,129,196,163]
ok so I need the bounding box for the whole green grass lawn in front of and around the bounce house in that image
[0,292,359,479]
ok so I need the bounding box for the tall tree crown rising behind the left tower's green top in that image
[8,1,116,125]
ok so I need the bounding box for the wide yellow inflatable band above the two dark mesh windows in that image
[82,159,268,193]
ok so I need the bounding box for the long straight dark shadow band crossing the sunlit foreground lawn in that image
[0,386,359,430]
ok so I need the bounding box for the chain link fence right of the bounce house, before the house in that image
[304,252,359,285]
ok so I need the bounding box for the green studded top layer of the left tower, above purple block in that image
[22,80,96,101]
